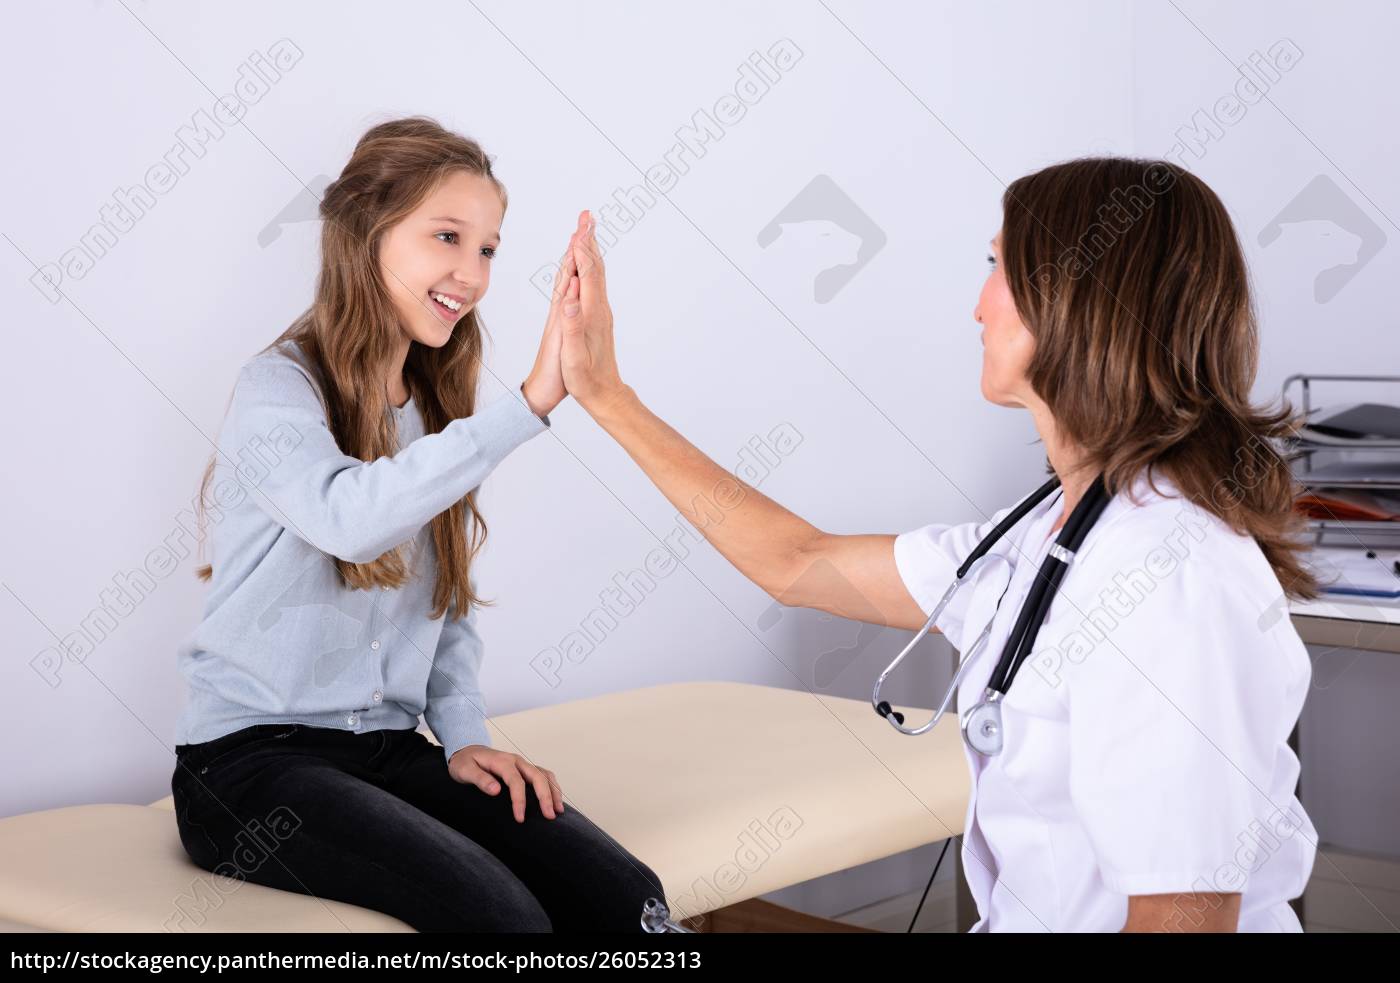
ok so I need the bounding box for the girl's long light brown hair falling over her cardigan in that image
[195,116,507,618]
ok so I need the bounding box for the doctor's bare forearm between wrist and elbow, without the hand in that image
[587,386,822,597]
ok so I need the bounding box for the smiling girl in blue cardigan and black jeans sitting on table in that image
[171,118,664,931]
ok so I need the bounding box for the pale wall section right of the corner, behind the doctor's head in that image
[1133,0,1400,402]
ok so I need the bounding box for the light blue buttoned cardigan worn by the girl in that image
[175,342,549,759]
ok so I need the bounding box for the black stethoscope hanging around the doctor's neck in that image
[871,475,1110,756]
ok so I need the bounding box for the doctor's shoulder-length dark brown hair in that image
[1001,157,1319,599]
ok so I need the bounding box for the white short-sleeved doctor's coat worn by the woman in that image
[895,475,1317,931]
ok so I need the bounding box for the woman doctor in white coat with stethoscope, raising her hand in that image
[548,158,1317,931]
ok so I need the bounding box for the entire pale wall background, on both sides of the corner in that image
[0,0,1400,910]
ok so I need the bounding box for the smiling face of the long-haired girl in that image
[379,171,505,349]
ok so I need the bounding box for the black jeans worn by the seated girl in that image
[171,724,665,933]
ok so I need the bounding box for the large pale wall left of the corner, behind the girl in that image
[0,3,1131,814]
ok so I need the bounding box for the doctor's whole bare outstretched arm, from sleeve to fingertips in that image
[560,213,927,632]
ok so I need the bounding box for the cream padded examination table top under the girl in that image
[0,682,969,931]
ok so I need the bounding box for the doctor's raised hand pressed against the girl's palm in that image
[560,211,627,416]
